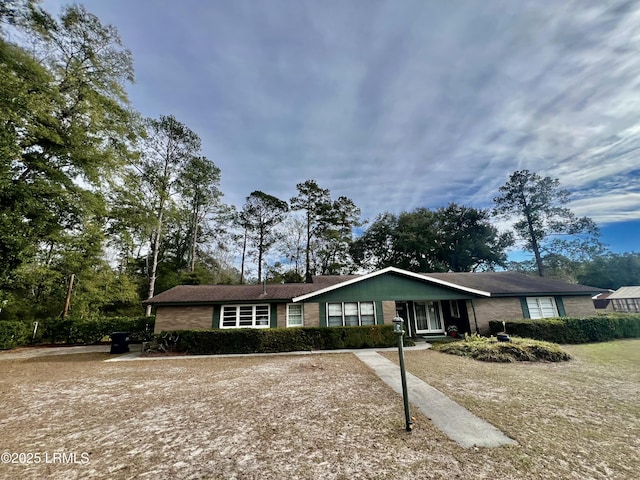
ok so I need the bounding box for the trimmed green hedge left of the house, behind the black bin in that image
[0,317,155,349]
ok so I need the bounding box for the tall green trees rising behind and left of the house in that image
[0,0,640,321]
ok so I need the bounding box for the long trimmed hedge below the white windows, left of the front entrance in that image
[165,325,408,355]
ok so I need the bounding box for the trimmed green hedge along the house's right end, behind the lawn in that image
[489,313,640,343]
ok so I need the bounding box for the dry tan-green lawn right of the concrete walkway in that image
[385,339,640,479]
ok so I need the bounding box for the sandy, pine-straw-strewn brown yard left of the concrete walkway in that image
[0,344,626,480]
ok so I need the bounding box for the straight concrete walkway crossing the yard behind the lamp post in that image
[354,350,517,448]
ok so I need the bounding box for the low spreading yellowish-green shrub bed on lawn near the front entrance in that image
[433,335,571,362]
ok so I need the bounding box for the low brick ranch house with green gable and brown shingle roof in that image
[145,267,602,337]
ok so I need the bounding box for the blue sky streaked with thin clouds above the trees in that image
[43,0,640,258]
